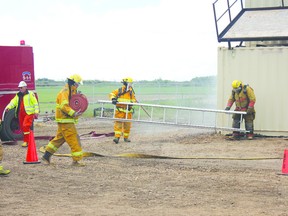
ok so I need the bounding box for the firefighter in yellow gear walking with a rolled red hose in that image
[42,74,84,166]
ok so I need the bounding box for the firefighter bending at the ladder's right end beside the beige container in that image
[225,80,256,140]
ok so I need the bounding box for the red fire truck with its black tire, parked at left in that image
[0,41,36,141]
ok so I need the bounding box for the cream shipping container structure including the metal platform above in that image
[214,0,288,135]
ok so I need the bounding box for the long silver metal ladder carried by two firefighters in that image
[94,100,247,132]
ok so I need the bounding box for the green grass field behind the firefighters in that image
[36,83,216,117]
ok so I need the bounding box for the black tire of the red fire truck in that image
[0,109,23,141]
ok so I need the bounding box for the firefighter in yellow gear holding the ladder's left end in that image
[109,78,137,144]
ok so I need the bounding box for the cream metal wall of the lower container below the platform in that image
[217,47,288,135]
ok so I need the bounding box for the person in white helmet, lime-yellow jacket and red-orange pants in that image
[5,81,39,147]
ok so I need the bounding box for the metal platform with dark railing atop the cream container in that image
[213,0,288,45]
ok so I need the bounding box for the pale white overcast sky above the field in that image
[0,0,219,81]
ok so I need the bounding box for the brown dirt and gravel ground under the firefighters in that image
[0,119,288,216]
